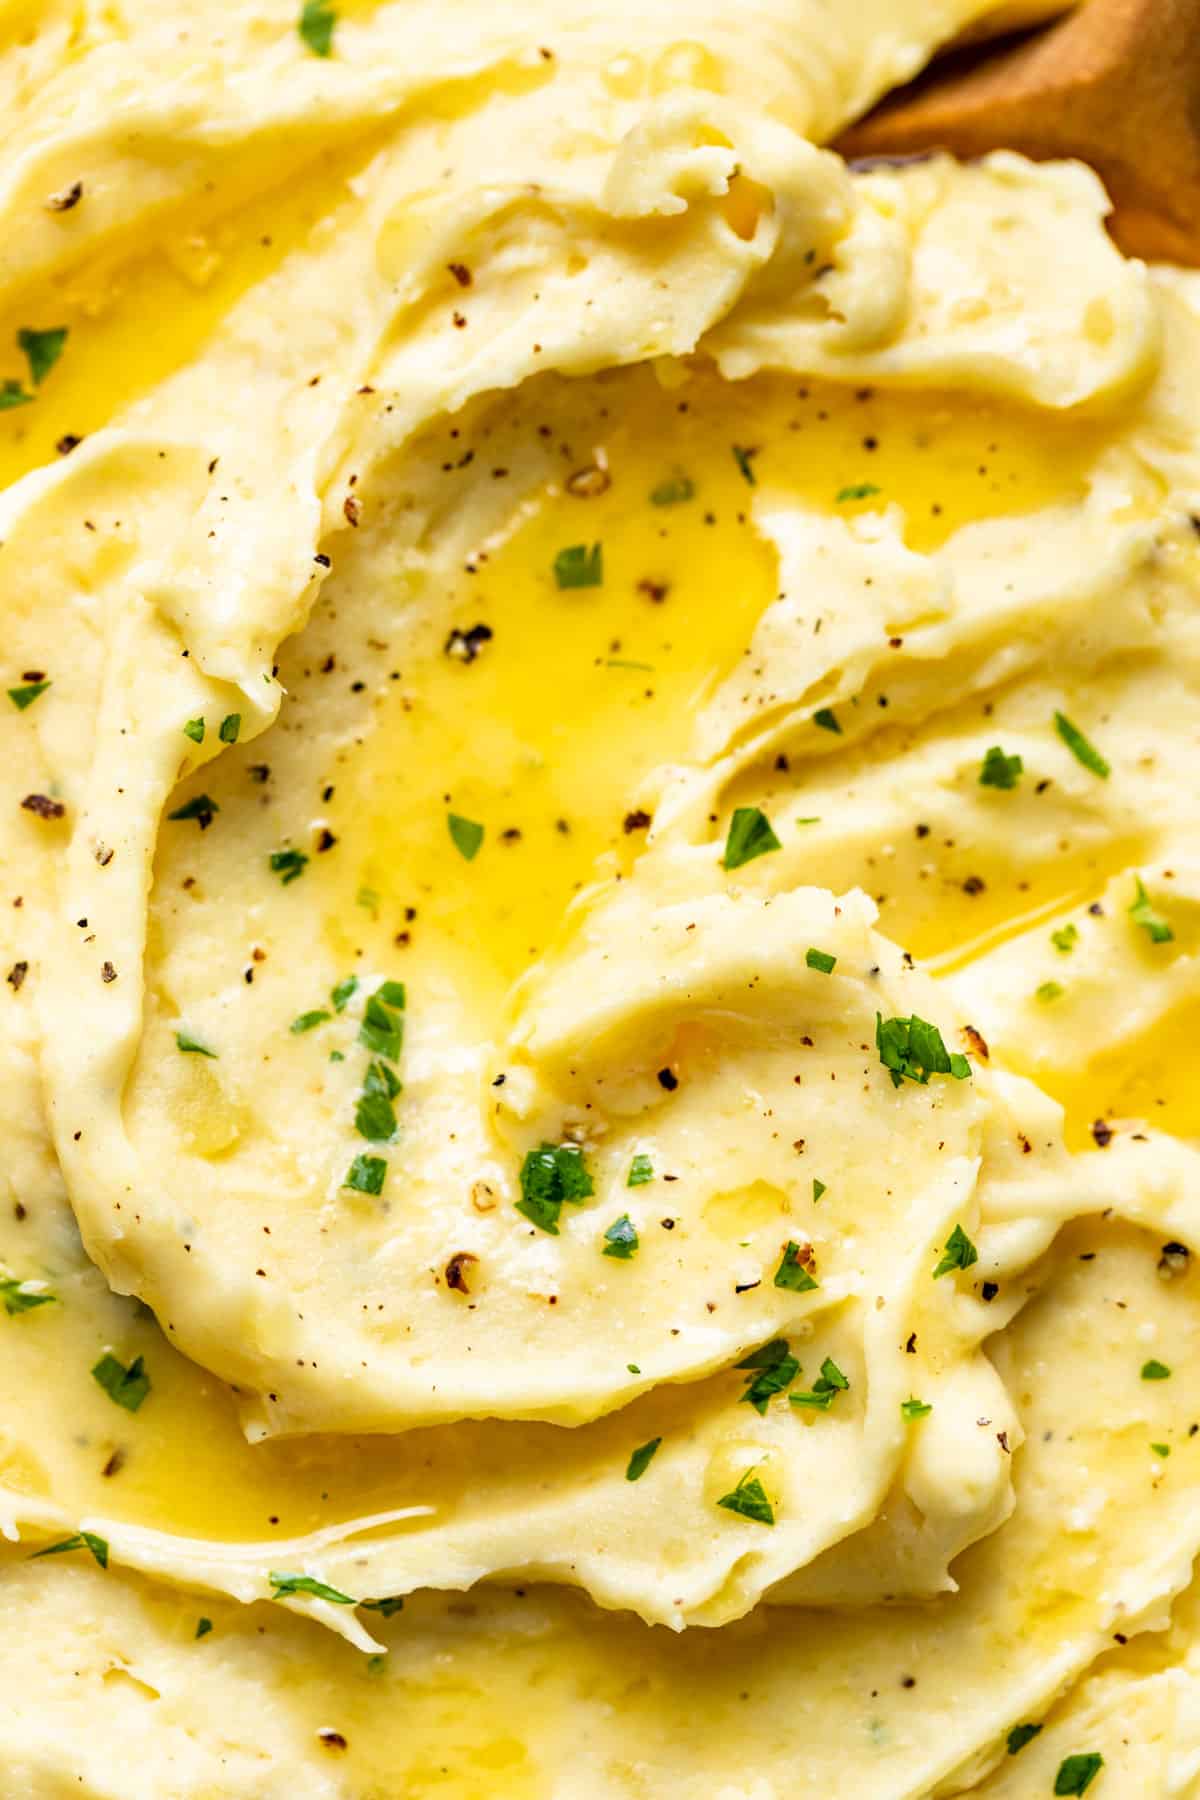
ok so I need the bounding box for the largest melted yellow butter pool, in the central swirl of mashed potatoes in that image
[314,371,1099,1030]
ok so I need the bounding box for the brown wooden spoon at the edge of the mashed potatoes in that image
[835,0,1200,265]
